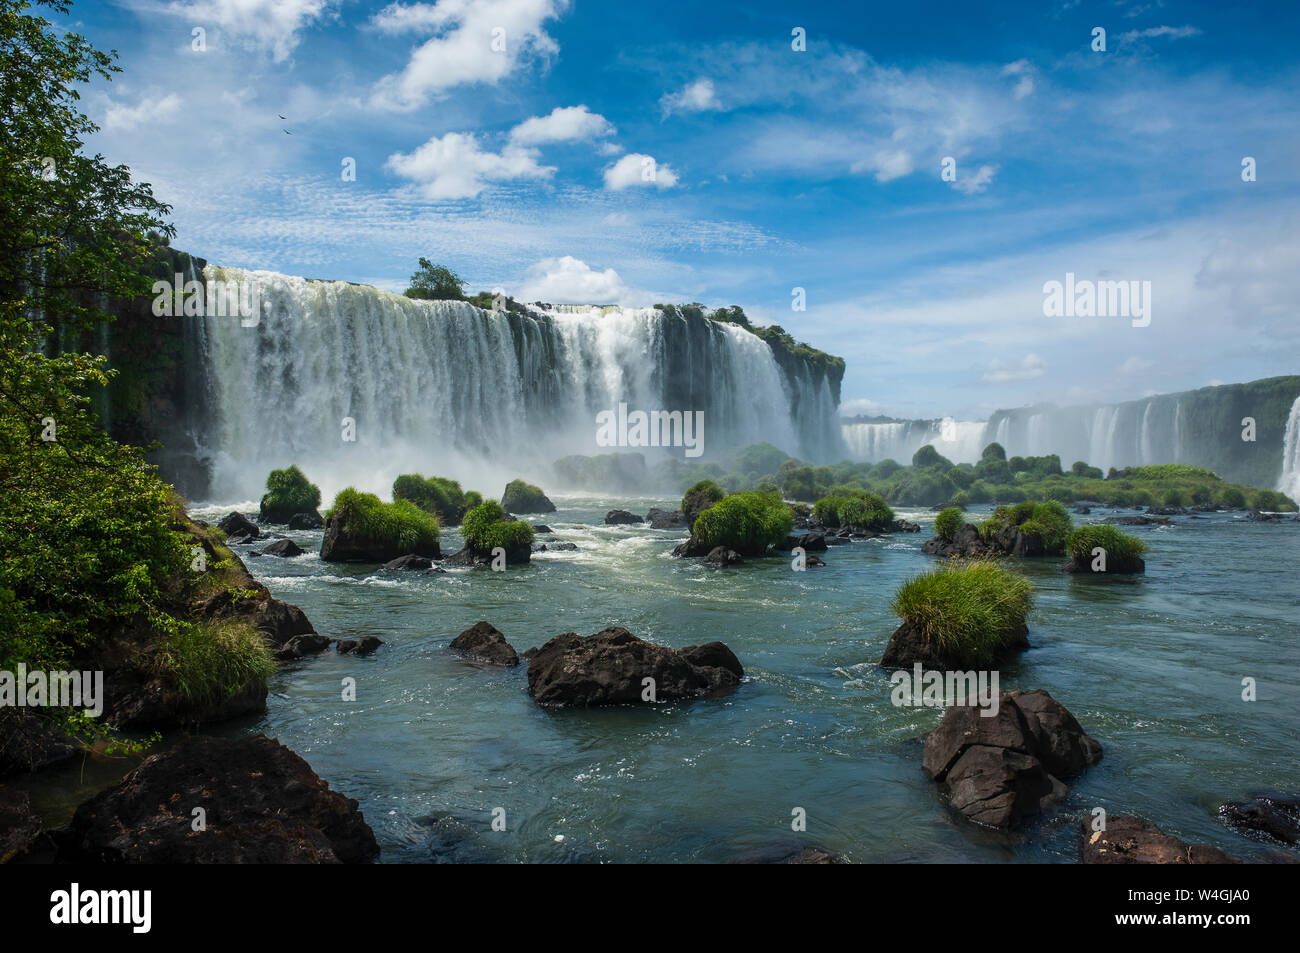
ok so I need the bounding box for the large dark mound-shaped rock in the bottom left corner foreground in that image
[57,735,380,863]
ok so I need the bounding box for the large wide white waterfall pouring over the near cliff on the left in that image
[187,265,842,504]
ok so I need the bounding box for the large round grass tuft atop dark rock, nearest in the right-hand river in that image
[889,560,1034,663]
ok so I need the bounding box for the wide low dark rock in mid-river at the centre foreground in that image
[528,627,744,707]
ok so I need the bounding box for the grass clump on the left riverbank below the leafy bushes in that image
[151,619,276,706]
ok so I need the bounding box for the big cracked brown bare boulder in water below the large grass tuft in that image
[922,690,1101,828]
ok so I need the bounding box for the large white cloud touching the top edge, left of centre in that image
[371,0,568,109]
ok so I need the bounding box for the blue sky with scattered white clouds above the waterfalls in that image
[65,0,1300,420]
